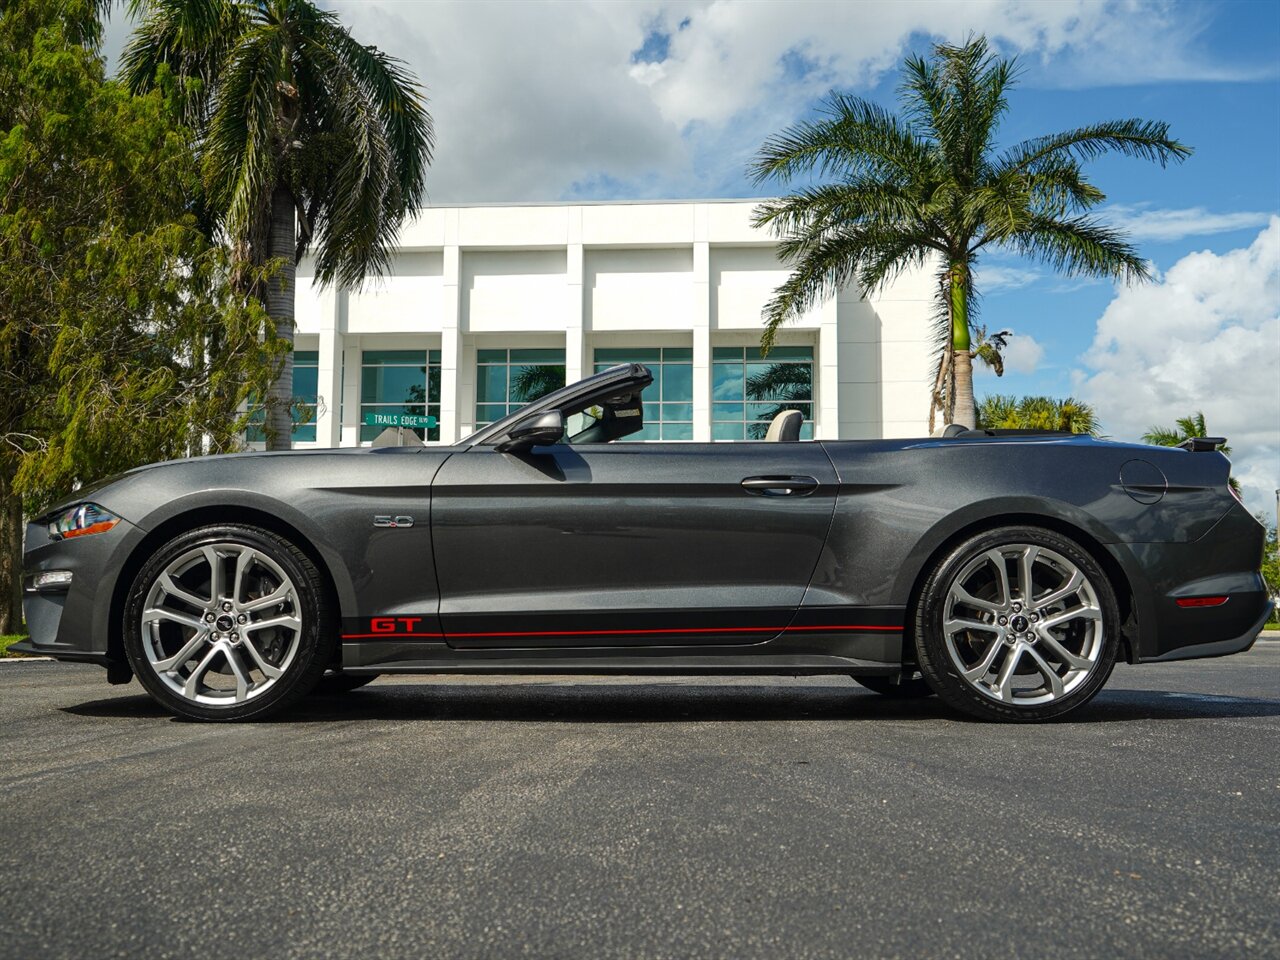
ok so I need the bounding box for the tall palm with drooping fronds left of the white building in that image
[122,0,434,449]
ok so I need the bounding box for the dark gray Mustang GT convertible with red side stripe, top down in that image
[15,365,1271,721]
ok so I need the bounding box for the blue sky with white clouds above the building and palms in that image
[99,0,1280,512]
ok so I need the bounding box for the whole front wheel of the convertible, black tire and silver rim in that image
[124,524,333,719]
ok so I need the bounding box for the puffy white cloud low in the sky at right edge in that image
[1076,216,1280,515]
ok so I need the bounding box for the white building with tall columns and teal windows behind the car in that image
[294,201,932,447]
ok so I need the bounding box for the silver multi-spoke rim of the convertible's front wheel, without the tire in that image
[138,541,303,707]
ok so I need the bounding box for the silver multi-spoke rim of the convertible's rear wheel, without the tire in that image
[942,543,1103,705]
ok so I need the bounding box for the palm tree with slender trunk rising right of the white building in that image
[750,37,1192,426]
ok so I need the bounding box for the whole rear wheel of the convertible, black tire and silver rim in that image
[914,526,1120,721]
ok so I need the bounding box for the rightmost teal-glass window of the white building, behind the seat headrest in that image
[712,347,813,440]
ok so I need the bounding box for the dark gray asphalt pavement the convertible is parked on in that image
[0,641,1280,960]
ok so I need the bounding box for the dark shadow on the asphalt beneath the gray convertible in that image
[63,678,1280,723]
